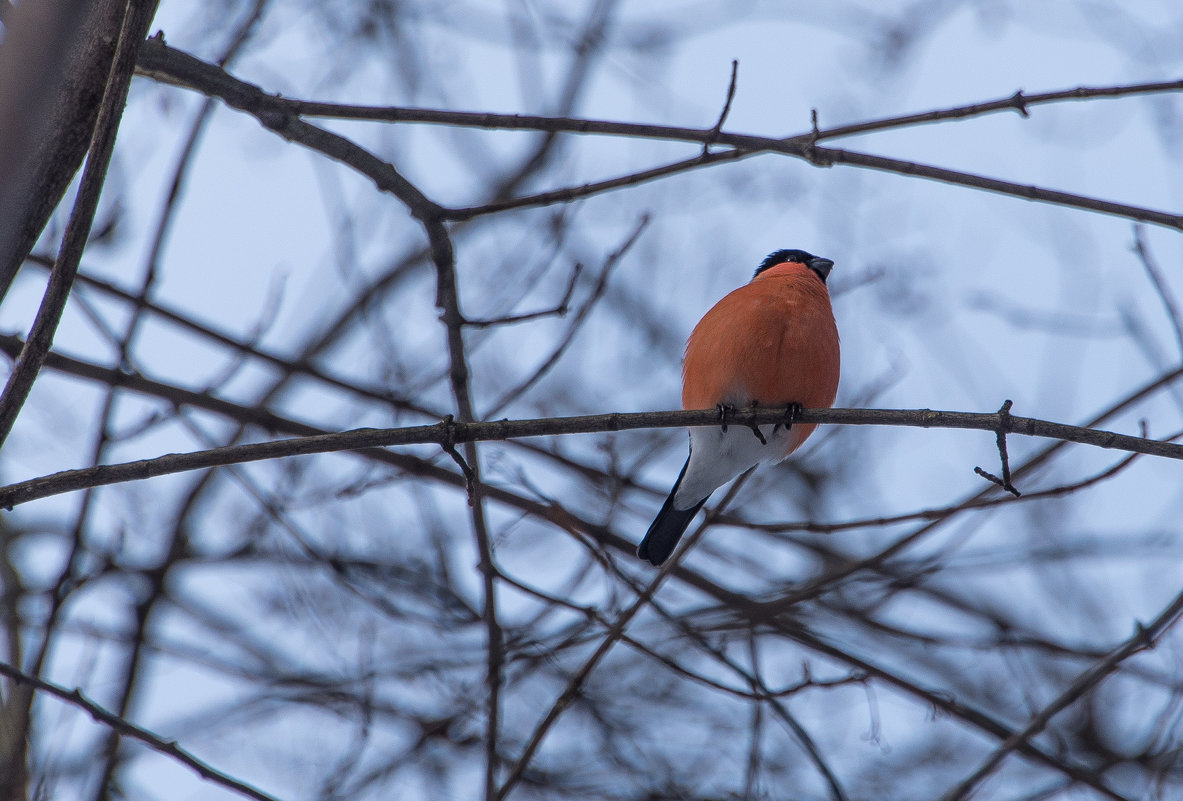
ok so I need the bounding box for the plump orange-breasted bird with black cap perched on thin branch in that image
[636,250,841,566]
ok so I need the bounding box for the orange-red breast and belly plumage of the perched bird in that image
[681,263,840,454]
